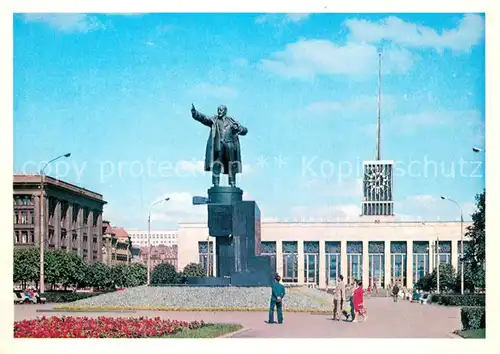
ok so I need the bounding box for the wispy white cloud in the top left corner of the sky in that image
[24,13,104,33]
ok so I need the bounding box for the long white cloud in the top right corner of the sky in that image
[346,14,484,51]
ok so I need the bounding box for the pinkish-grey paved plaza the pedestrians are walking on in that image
[14,298,460,338]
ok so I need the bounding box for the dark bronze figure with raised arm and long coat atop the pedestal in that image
[191,105,248,187]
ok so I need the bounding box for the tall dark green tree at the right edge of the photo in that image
[464,190,486,289]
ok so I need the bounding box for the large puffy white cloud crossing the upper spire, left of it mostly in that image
[260,39,413,79]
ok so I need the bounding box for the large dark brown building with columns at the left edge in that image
[13,174,106,262]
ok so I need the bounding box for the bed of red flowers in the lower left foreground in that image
[14,316,205,338]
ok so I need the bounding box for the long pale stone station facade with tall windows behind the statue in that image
[178,218,470,288]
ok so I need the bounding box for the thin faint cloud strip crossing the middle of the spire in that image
[306,95,396,115]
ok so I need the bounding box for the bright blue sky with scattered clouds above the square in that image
[14,14,485,228]
